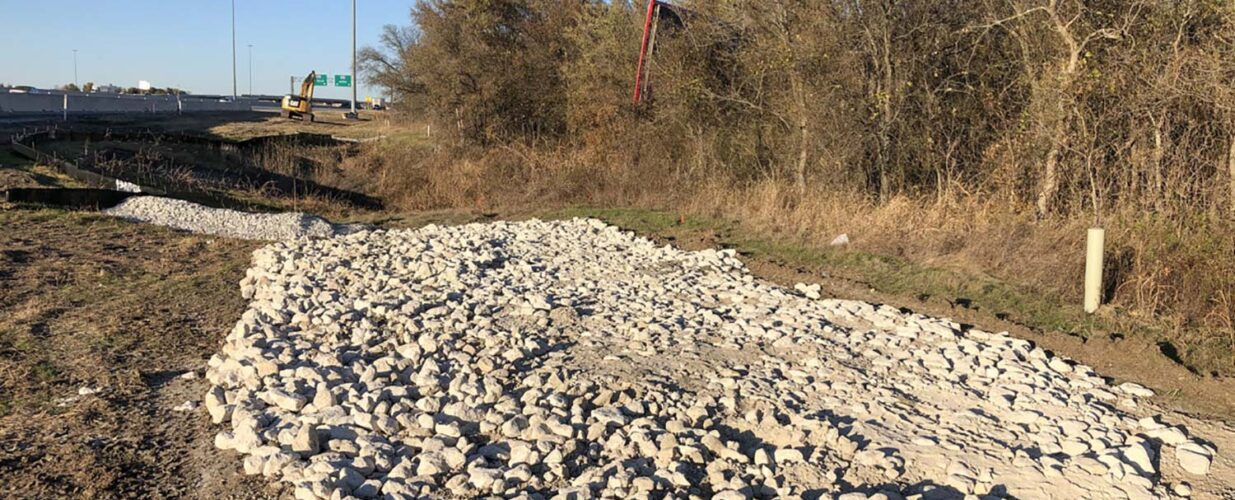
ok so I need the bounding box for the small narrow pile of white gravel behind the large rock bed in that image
[104,196,357,241]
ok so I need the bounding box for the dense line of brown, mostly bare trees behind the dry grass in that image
[362,0,1235,217]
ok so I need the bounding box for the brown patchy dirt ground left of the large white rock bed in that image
[0,210,269,498]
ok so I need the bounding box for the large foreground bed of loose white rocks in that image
[205,220,1214,499]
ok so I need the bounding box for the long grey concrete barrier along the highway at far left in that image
[0,93,258,116]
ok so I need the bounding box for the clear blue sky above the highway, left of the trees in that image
[0,0,415,99]
